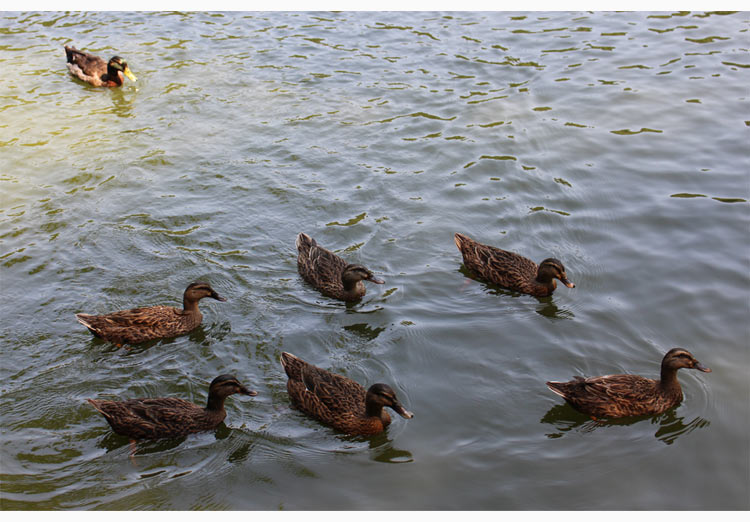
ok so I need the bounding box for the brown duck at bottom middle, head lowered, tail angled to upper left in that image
[281,352,414,436]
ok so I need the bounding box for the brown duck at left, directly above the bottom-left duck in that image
[76,281,231,346]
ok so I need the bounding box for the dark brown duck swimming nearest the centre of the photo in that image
[296,232,385,302]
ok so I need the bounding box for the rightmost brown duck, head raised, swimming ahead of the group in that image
[547,348,711,418]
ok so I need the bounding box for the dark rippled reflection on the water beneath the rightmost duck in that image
[540,403,711,445]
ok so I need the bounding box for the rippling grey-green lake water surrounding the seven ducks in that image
[0,12,750,510]
